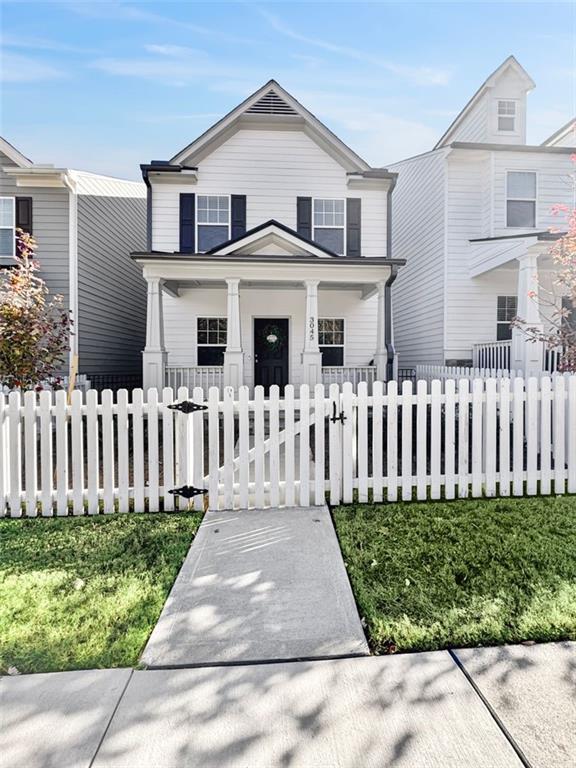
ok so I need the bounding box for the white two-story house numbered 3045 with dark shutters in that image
[133,80,402,388]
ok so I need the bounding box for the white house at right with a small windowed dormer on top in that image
[390,56,576,373]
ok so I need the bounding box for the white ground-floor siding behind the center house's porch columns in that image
[163,284,377,386]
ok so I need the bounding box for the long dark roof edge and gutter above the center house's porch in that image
[130,251,406,268]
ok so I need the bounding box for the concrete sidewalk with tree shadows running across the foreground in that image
[0,643,576,768]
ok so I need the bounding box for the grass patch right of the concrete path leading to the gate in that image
[334,497,576,653]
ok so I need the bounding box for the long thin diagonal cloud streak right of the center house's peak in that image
[258,8,450,85]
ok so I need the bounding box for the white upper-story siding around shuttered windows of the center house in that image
[152,130,386,256]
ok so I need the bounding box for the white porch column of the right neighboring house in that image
[510,251,544,378]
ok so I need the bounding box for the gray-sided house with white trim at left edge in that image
[0,138,146,388]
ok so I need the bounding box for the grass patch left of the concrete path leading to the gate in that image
[0,513,201,672]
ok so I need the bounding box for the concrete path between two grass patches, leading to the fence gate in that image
[142,507,369,668]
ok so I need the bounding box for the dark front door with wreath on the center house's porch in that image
[254,317,289,392]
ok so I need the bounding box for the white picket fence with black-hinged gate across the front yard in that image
[0,376,576,517]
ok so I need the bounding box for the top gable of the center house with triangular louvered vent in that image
[169,80,370,171]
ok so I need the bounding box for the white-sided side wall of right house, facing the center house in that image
[391,150,445,366]
